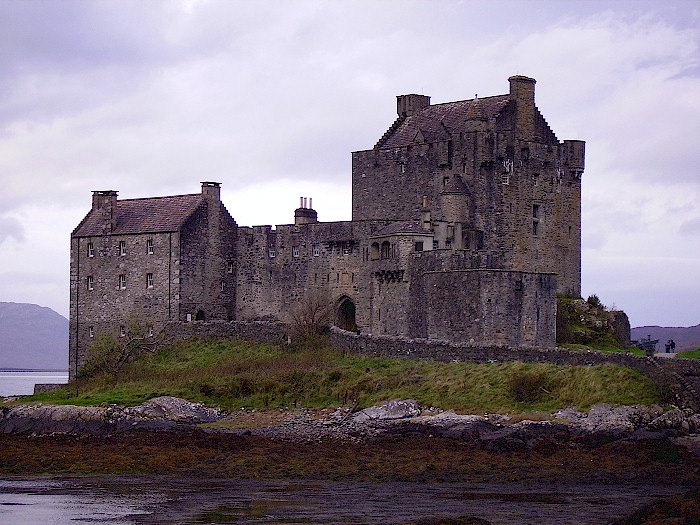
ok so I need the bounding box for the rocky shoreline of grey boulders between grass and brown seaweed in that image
[0,396,700,451]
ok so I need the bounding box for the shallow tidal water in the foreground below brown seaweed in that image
[0,476,688,525]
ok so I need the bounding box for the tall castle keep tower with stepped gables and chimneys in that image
[352,75,585,295]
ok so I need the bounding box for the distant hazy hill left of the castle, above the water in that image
[0,302,68,370]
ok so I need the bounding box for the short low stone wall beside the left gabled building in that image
[163,321,287,344]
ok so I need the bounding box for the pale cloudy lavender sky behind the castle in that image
[0,0,700,326]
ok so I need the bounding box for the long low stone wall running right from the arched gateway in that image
[330,327,700,410]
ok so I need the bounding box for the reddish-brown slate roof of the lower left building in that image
[73,193,203,237]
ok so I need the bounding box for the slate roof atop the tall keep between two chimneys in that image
[378,95,510,148]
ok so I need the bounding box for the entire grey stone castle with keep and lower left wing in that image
[70,76,585,377]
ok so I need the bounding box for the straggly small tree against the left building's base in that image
[78,321,159,377]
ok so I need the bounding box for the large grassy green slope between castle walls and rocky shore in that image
[23,340,661,414]
